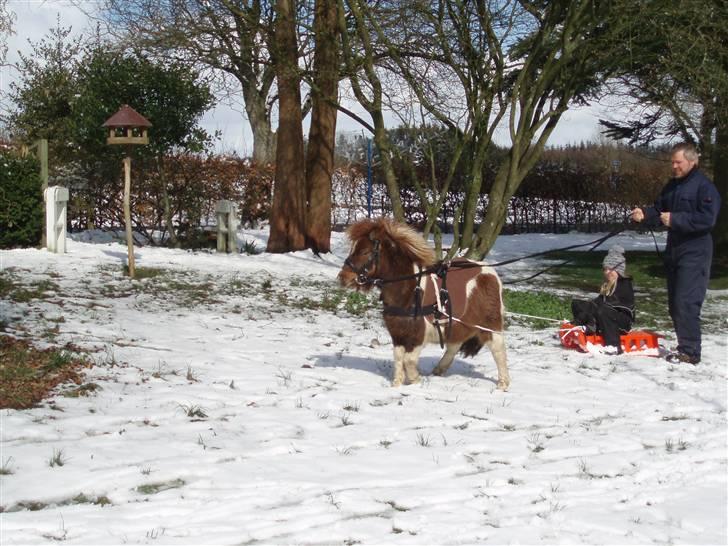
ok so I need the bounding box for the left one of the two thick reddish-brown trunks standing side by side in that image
[267,0,306,252]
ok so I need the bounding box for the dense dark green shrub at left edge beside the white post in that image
[0,150,44,248]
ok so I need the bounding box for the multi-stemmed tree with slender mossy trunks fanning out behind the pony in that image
[344,0,608,257]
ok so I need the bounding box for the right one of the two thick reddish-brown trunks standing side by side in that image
[306,0,339,253]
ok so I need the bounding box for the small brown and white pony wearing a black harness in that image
[339,219,510,390]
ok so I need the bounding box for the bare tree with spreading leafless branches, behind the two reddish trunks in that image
[101,0,276,164]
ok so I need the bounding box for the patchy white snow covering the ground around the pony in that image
[0,230,728,545]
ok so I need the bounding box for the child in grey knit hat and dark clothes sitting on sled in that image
[571,245,634,354]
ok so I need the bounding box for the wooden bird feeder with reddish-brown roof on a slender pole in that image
[102,104,152,279]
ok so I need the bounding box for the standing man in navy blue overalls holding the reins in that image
[632,143,720,364]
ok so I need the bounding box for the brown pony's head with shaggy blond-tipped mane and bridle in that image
[339,218,435,291]
